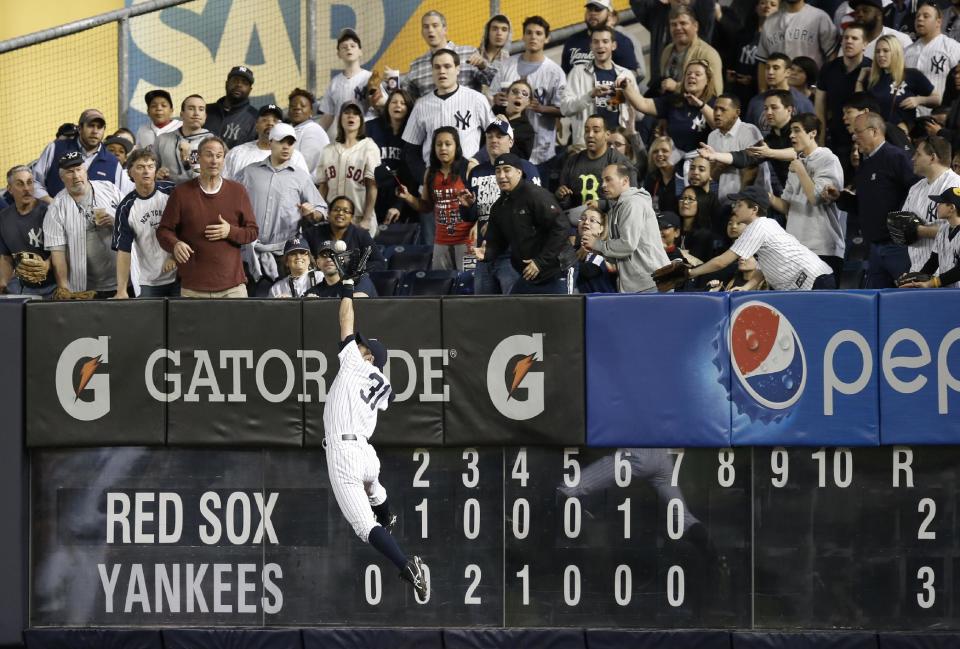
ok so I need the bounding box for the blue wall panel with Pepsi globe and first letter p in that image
[727,291,880,446]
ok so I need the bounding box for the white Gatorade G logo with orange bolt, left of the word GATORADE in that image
[54,336,110,421]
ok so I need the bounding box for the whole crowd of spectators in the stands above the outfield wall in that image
[0,0,960,299]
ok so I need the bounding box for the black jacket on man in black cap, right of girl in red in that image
[485,180,572,284]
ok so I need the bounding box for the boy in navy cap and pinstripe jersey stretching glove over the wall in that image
[668,185,837,291]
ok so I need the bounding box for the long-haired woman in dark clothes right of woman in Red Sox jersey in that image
[366,88,417,223]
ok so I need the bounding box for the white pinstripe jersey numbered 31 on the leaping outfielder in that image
[323,337,391,444]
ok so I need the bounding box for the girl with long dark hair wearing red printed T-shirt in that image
[398,126,477,271]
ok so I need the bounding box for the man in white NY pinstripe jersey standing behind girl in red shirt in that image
[403,49,493,166]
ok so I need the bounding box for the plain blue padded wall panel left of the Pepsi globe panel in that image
[586,293,730,447]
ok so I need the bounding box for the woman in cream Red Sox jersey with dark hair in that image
[316,101,380,237]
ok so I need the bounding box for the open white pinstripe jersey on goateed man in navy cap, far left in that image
[43,180,121,291]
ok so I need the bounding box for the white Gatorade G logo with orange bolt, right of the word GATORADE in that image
[487,333,545,421]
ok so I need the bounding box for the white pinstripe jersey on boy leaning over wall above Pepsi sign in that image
[730,217,833,291]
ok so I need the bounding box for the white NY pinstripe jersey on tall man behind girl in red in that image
[403,86,493,164]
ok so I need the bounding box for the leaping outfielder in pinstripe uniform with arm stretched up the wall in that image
[323,279,430,601]
